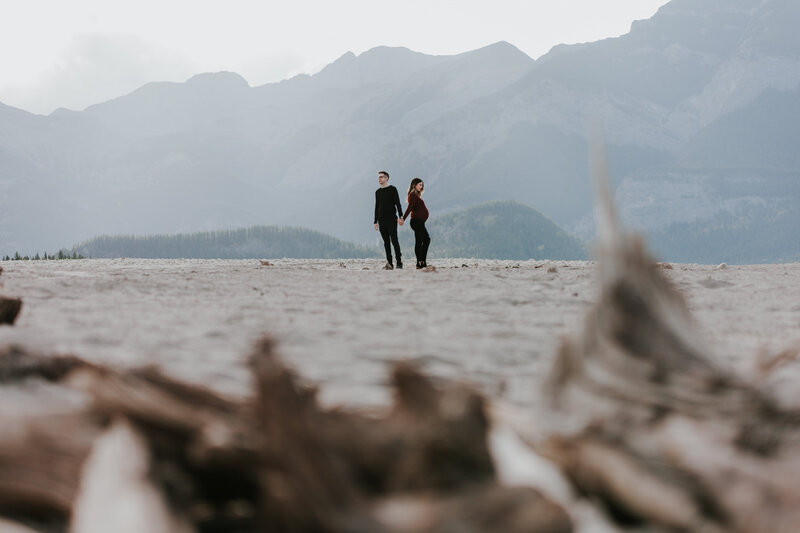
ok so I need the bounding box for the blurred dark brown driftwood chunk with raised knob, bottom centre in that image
[319,363,495,495]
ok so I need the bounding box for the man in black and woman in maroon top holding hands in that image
[374,170,431,270]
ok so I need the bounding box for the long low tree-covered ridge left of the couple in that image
[75,226,376,259]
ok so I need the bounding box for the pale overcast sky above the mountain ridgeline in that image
[0,0,667,114]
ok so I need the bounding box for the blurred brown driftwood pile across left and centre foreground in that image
[0,340,572,533]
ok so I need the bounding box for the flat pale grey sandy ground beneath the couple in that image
[0,259,800,406]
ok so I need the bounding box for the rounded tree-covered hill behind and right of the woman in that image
[400,201,587,261]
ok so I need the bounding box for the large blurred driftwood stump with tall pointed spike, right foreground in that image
[538,144,800,533]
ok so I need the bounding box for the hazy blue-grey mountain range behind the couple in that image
[0,0,800,262]
